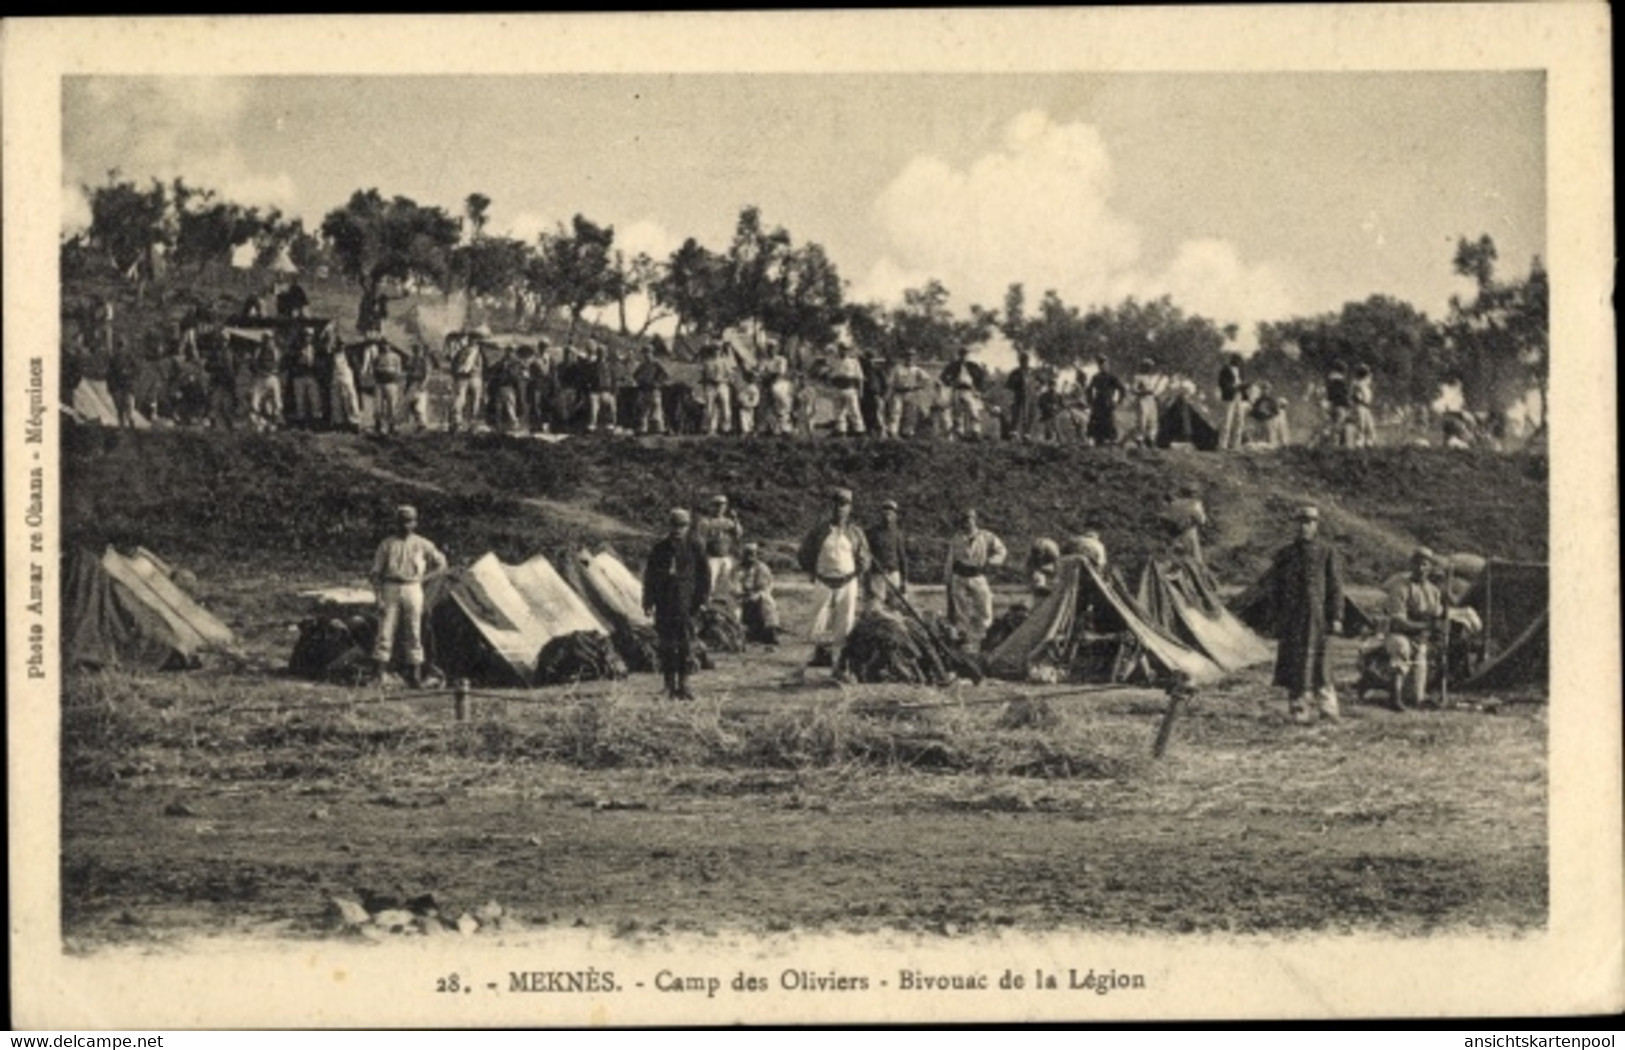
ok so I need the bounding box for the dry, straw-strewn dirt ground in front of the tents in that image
[62,577,1547,951]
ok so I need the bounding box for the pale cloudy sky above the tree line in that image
[62,73,1545,345]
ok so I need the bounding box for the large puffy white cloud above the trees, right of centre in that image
[853,111,1290,338]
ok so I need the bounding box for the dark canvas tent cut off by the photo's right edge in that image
[1458,561,1552,691]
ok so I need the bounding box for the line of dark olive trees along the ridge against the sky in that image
[62,172,1549,410]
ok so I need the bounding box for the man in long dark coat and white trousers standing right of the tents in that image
[1271,507,1342,725]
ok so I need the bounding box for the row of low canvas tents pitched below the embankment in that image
[63,548,1550,689]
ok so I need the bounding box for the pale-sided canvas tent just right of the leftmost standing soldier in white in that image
[424,554,606,686]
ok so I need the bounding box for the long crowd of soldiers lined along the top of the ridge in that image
[73,280,1436,449]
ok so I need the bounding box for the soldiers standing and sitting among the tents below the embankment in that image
[371,488,1448,723]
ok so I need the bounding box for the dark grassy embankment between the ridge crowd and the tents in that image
[62,427,1549,584]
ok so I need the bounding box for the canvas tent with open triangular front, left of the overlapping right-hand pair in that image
[986,556,1224,683]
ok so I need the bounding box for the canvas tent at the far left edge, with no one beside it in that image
[62,548,236,670]
